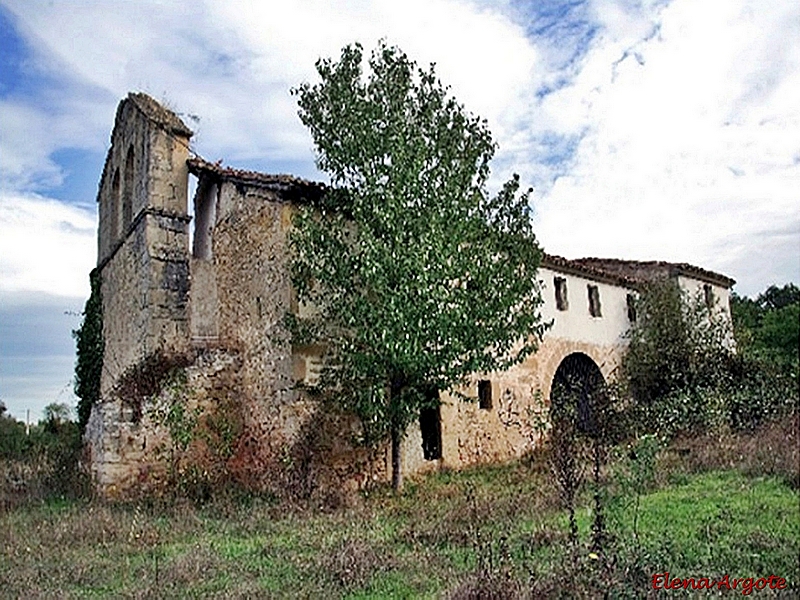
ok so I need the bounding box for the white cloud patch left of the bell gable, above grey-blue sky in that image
[0,193,96,297]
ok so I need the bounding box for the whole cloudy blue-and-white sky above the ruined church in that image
[0,0,800,420]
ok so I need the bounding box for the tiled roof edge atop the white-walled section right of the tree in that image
[542,255,736,288]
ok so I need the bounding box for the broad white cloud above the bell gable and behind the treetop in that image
[3,0,536,169]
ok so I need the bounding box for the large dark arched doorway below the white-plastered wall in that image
[550,352,607,437]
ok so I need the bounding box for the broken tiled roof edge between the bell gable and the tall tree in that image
[186,157,327,202]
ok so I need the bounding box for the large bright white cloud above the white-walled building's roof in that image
[524,0,800,293]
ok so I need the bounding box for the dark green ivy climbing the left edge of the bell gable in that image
[72,269,104,432]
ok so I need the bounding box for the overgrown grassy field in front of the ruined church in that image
[0,424,800,598]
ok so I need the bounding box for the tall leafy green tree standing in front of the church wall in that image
[291,43,545,488]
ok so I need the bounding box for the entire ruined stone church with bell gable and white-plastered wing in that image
[86,94,734,497]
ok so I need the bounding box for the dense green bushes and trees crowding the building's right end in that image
[623,282,800,434]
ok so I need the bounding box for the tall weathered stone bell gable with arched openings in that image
[97,93,192,395]
